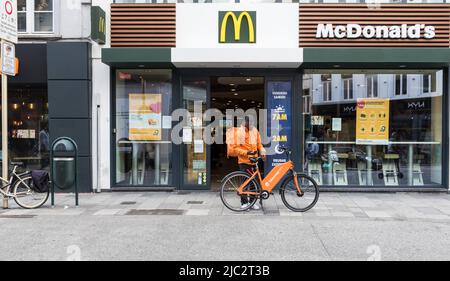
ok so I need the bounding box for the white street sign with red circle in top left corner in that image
[0,0,17,44]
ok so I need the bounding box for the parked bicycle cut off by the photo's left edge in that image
[0,162,50,209]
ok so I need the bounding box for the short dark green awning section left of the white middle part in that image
[102,48,172,68]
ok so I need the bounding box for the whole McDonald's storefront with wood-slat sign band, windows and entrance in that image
[100,3,450,191]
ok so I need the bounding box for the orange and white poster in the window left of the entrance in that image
[129,94,162,141]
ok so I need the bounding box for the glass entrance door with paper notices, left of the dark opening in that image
[181,79,210,189]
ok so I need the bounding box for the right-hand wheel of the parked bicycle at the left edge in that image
[13,176,50,209]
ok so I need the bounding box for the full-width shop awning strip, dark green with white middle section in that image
[102,48,450,68]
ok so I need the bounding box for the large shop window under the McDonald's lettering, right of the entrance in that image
[303,70,443,187]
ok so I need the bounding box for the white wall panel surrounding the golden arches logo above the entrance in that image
[172,3,303,68]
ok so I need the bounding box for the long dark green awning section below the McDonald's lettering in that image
[302,48,450,68]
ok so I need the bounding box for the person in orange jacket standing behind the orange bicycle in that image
[233,116,266,210]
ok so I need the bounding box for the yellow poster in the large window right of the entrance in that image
[356,99,389,145]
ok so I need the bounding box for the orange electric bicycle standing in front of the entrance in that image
[220,147,319,212]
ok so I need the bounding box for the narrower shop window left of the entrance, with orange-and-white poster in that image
[115,69,172,186]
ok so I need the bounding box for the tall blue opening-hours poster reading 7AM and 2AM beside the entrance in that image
[265,81,292,173]
